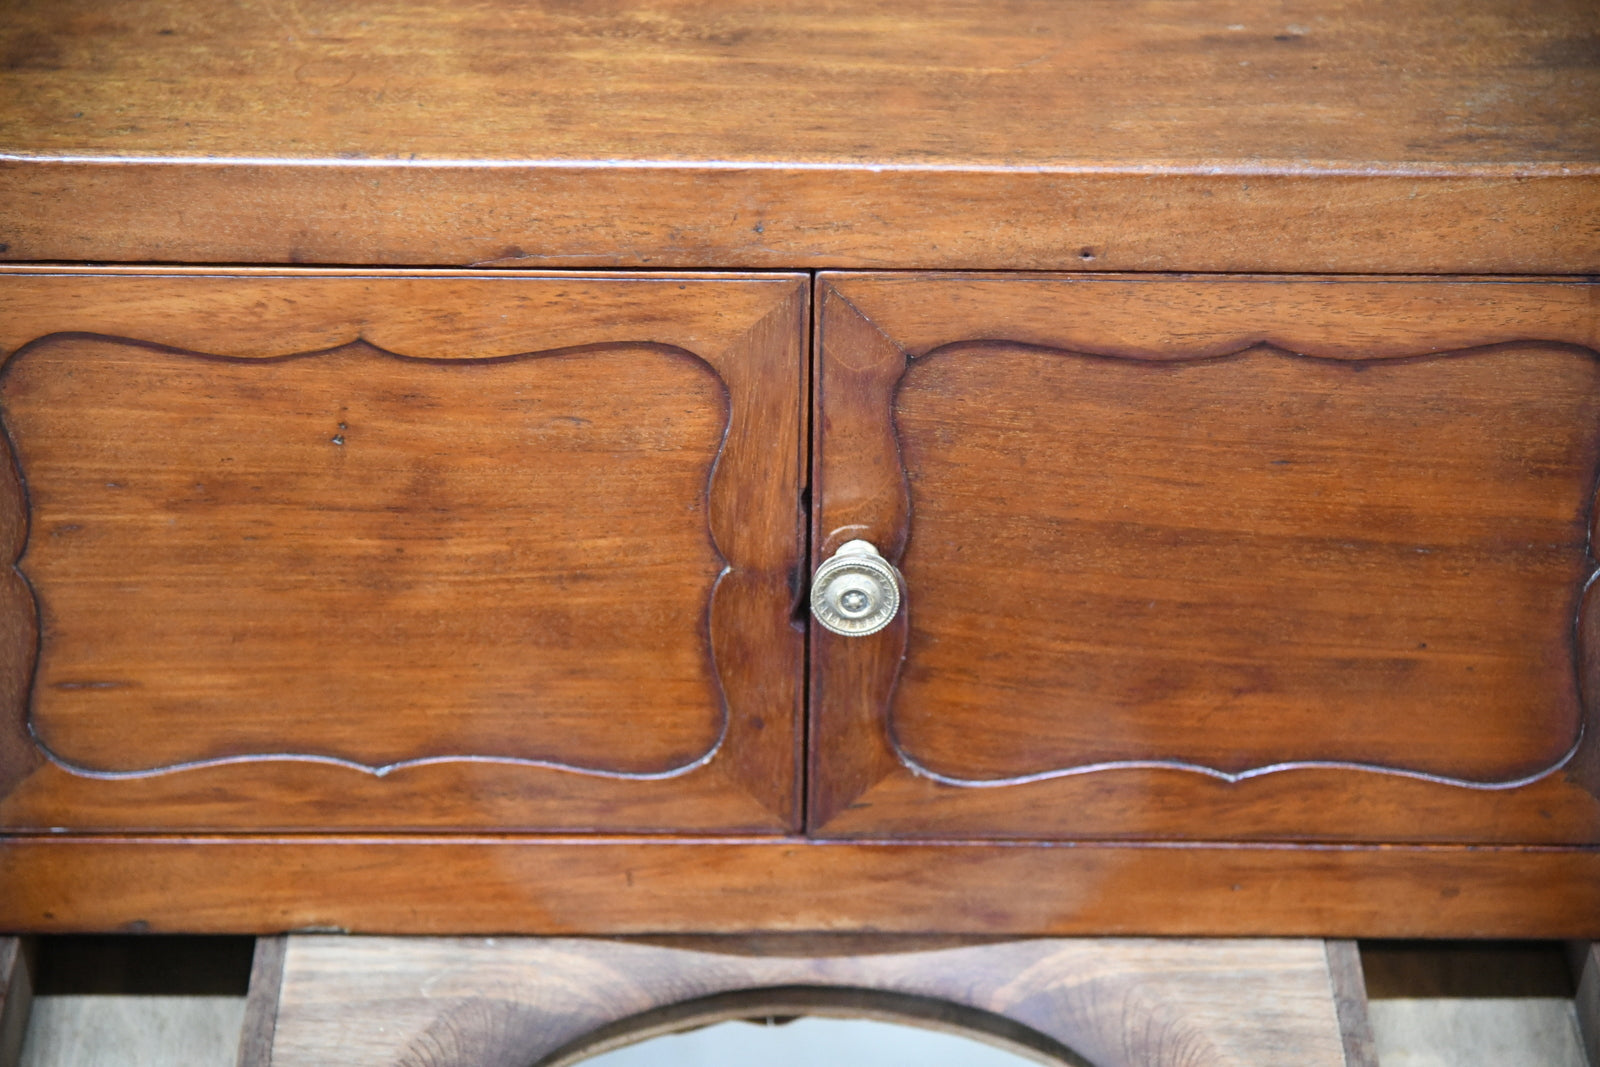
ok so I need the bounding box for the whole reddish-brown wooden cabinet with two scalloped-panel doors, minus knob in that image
[0,0,1600,937]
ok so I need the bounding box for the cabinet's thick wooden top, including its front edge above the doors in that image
[0,0,1600,272]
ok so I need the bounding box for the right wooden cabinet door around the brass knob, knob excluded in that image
[810,274,1600,843]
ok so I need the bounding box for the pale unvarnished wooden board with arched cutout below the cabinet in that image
[265,936,1371,1067]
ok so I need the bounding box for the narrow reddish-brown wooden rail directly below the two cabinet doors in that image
[0,835,1600,937]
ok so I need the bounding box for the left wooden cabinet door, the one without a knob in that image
[0,269,808,832]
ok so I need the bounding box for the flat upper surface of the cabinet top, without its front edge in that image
[15,0,1600,165]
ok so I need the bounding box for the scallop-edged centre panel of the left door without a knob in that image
[0,339,726,777]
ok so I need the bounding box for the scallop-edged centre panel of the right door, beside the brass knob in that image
[891,342,1600,784]
